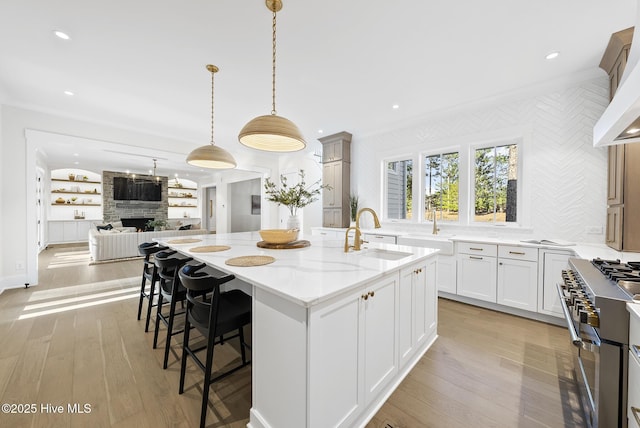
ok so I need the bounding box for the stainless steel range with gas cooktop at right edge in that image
[558,259,640,428]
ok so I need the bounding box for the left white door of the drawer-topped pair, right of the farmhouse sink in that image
[457,254,496,303]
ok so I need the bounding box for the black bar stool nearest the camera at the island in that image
[178,264,251,428]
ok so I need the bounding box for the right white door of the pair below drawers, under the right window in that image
[497,258,538,312]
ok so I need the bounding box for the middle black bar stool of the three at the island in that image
[153,251,193,369]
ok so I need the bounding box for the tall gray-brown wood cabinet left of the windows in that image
[318,132,351,227]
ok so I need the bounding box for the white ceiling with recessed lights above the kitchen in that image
[0,0,636,177]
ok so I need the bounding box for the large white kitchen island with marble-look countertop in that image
[159,232,437,428]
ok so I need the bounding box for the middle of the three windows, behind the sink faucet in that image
[423,152,459,221]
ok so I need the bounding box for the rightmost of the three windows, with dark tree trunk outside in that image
[474,144,518,223]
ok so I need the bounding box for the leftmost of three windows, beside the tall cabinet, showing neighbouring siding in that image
[386,159,413,220]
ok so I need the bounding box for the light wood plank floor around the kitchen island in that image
[0,246,584,428]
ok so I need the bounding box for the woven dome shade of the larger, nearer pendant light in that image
[238,114,307,152]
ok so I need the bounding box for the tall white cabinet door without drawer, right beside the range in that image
[538,251,571,317]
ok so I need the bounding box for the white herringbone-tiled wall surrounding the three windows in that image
[351,77,608,243]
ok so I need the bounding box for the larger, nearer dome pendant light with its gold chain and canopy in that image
[238,0,307,152]
